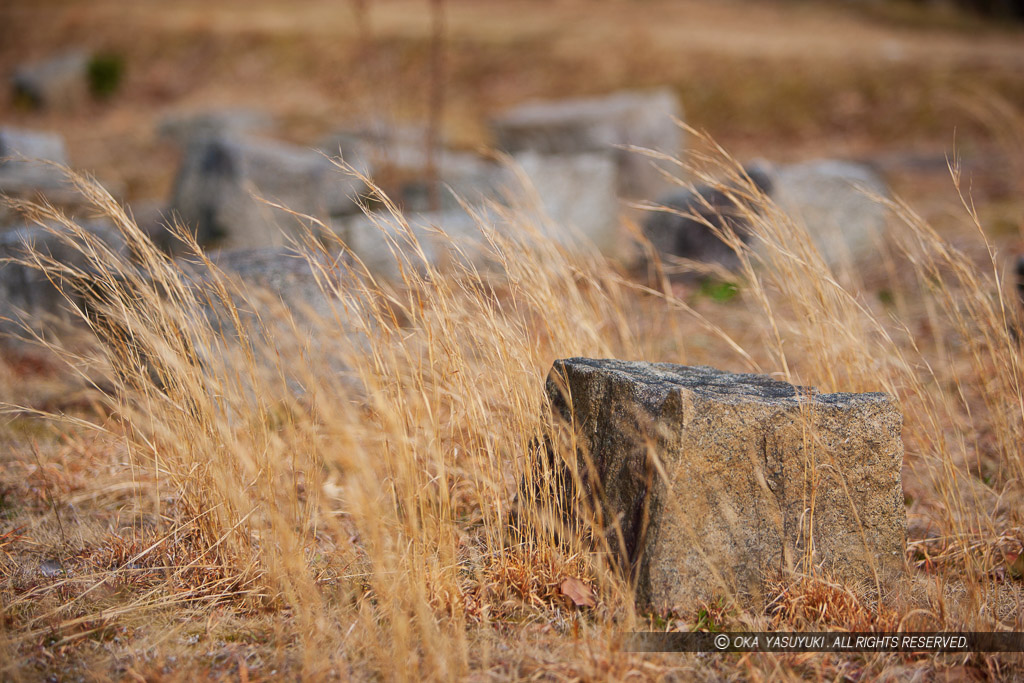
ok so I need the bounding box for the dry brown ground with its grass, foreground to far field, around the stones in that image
[0,0,1024,680]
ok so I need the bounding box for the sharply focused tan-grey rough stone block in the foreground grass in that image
[547,358,906,611]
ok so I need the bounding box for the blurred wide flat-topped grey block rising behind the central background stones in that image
[492,89,683,200]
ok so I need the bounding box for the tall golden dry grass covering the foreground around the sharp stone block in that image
[0,127,1024,680]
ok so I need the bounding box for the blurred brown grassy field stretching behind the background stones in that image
[6,0,1024,210]
